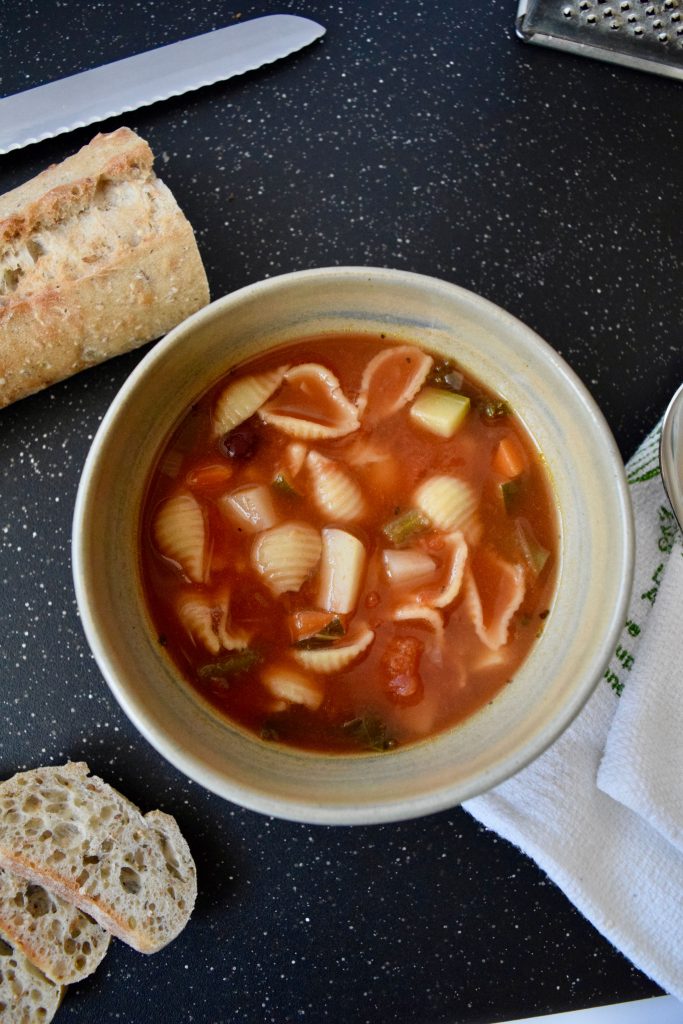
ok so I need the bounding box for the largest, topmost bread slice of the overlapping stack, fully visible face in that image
[0,762,197,953]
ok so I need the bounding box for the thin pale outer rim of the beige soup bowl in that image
[72,265,635,824]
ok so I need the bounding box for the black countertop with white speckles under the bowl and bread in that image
[0,0,683,1024]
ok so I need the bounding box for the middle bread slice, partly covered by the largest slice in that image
[0,868,111,983]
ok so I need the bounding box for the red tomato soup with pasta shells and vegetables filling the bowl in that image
[140,335,559,754]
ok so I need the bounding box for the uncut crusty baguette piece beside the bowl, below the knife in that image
[0,128,209,408]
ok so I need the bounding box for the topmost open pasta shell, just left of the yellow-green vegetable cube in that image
[356,345,434,426]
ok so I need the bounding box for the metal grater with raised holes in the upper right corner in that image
[516,0,683,79]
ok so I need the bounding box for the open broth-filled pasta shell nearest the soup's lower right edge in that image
[464,548,524,650]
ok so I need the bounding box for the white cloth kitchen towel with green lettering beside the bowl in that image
[464,427,683,1000]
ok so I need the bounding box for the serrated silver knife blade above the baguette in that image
[0,14,326,154]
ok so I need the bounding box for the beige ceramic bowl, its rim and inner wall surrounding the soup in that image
[73,267,633,824]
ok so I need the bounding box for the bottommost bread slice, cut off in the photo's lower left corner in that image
[0,933,62,1024]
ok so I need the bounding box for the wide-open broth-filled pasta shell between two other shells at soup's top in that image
[259,362,358,440]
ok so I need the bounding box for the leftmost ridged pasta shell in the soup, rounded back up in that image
[153,494,210,583]
